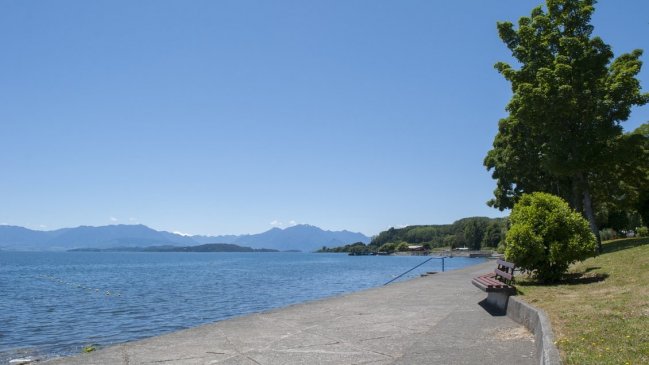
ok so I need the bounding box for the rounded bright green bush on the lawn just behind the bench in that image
[505,193,596,282]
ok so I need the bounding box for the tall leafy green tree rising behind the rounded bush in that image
[484,0,649,250]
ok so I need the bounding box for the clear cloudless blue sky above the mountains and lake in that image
[0,0,649,235]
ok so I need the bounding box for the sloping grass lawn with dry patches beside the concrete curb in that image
[517,238,649,364]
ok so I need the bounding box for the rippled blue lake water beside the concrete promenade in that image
[0,252,484,364]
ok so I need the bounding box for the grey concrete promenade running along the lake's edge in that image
[46,262,538,365]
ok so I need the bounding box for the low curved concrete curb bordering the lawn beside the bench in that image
[507,297,561,365]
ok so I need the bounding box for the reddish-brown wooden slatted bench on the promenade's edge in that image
[471,259,516,311]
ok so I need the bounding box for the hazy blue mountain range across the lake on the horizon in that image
[0,224,370,252]
